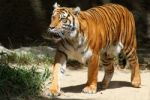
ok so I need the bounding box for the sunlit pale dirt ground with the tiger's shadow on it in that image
[46,68,150,100]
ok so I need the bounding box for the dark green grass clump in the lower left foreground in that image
[0,64,50,97]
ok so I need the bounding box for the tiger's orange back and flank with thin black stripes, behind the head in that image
[80,4,136,54]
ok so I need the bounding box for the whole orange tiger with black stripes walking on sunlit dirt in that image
[48,3,141,95]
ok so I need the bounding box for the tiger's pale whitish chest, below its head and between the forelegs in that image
[59,36,93,64]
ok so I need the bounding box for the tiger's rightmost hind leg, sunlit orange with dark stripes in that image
[125,48,141,87]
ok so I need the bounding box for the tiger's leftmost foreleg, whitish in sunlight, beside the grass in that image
[49,51,66,96]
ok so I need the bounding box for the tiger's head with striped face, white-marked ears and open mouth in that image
[48,3,80,38]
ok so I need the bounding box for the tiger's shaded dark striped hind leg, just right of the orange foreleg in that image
[101,53,114,89]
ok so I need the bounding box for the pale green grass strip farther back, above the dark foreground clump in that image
[0,52,53,65]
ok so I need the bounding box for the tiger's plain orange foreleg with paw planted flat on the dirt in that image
[83,54,99,93]
